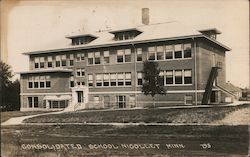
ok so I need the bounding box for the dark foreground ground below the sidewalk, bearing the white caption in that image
[1,125,249,157]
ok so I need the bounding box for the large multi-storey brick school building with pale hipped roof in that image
[20,10,235,111]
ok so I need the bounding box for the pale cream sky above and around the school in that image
[1,0,250,88]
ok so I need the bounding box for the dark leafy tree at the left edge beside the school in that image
[0,61,20,111]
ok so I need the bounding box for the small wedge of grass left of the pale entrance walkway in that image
[1,111,55,123]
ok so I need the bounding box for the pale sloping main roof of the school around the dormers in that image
[24,21,230,55]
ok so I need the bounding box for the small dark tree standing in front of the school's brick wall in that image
[142,61,166,107]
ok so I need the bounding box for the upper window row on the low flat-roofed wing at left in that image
[28,76,51,88]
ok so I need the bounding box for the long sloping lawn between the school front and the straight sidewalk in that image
[24,104,250,123]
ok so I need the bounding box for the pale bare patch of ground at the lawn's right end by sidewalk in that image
[215,108,250,125]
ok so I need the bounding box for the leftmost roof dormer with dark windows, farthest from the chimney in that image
[66,34,97,45]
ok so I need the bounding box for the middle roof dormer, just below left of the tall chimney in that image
[110,29,142,41]
